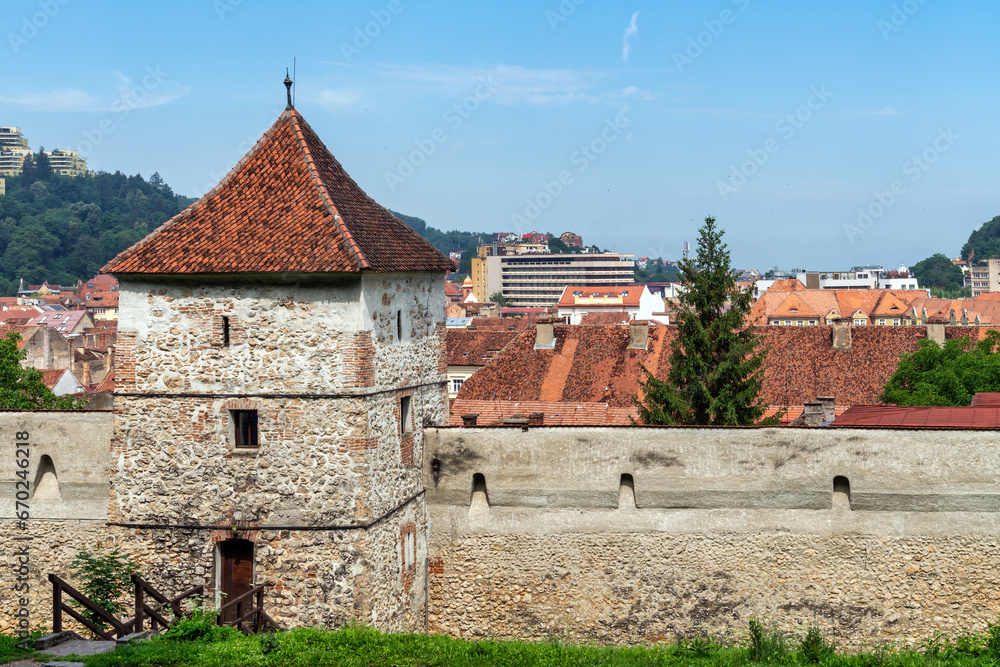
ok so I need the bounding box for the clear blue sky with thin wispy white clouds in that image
[0,0,1000,270]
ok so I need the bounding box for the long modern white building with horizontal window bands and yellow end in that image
[472,245,635,308]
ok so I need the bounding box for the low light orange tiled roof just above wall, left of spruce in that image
[450,398,636,426]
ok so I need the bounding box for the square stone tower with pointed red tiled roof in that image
[103,104,453,631]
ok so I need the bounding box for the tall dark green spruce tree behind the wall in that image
[633,217,778,426]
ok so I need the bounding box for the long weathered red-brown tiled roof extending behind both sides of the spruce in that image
[458,325,985,407]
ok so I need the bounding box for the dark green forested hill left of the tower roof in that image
[0,170,195,296]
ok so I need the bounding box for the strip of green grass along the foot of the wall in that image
[0,619,1000,667]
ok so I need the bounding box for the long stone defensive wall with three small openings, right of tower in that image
[424,427,1000,647]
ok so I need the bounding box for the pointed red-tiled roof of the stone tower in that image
[101,109,455,275]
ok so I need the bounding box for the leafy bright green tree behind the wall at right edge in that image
[879,330,1000,405]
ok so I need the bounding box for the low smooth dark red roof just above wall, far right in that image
[830,405,1000,429]
